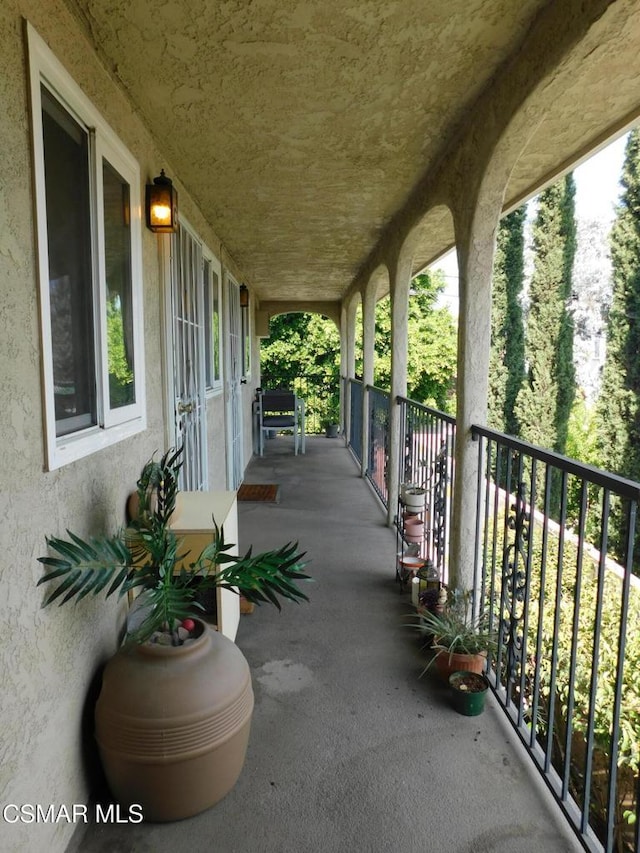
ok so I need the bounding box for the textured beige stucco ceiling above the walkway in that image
[67,0,640,300]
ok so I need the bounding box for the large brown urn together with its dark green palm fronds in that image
[38,450,309,821]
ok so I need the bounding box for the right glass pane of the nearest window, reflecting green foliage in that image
[102,160,136,409]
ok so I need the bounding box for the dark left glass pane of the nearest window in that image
[42,86,97,436]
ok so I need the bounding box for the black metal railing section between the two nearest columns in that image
[397,397,456,584]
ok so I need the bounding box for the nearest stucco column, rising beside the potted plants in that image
[449,210,501,590]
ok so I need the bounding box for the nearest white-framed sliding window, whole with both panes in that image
[27,25,146,469]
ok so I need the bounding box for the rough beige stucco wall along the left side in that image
[0,0,245,853]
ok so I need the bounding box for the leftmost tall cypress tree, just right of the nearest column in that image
[489,205,527,435]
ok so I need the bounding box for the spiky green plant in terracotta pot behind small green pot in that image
[417,590,496,681]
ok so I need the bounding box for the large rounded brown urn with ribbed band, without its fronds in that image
[95,620,253,821]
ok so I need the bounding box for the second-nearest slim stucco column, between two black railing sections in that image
[387,256,411,525]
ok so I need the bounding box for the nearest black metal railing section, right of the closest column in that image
[472,427,640,853]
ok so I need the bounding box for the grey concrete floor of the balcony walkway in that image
[76,437,582,853]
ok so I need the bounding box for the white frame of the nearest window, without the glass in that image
[27,23,147,470]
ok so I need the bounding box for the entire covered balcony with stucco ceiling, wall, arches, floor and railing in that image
[5,0,640,853]
